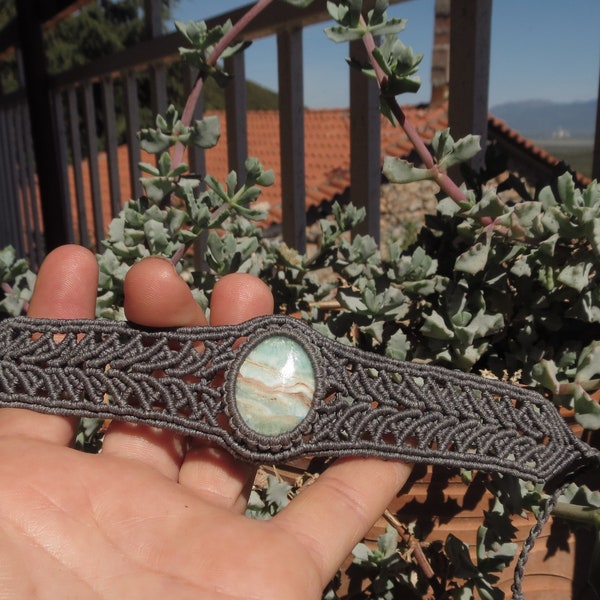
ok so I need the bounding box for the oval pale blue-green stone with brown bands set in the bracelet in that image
[235,335,315,435]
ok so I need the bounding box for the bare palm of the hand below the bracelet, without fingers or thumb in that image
[0,438,323,599]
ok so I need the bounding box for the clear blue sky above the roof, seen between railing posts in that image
[174,0,600,108]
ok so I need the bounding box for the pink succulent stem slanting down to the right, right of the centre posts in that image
[361,17,467,204]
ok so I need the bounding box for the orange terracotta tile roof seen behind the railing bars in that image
[64,105,585,246]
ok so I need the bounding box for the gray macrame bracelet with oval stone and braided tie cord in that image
[0,316,600,597]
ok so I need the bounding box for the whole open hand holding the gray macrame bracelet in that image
[0,246,410,600]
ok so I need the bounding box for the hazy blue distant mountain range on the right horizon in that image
[490,100,596,139]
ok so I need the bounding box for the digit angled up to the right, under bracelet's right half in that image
[271,458,412,586]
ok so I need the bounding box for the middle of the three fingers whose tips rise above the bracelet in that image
[102,256,206,480]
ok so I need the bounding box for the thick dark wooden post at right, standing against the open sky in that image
[448,0,492,169]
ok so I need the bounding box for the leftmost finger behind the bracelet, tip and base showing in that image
[0,245,98,445]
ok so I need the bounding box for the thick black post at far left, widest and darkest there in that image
[17,0,69,251]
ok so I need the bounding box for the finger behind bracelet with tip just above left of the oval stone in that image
[179,273,273,512]
